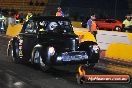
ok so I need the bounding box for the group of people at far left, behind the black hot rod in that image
[0,11,38,33]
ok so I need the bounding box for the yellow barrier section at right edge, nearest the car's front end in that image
[105,43,132,63]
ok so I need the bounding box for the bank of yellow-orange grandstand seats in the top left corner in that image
[0,0,49,14]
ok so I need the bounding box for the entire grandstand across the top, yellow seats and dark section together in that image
[0,0,132,20]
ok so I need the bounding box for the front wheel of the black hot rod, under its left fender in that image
[33,49,49,72]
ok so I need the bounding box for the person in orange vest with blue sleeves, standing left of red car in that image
[87,14,97,39]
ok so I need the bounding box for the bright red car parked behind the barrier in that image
[96,19,122,31]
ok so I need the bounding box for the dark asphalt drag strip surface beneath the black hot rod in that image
[0,34,132,88]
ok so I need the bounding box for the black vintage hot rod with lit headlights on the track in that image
[7,16,99,71]
